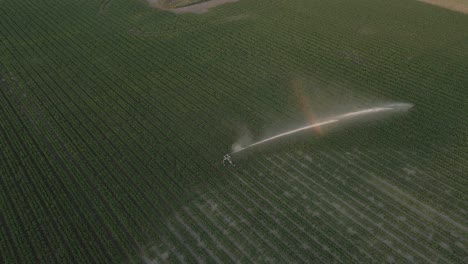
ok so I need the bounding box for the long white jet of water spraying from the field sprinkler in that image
[231,103,413,154]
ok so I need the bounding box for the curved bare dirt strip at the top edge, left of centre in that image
[147,0,239,14]
